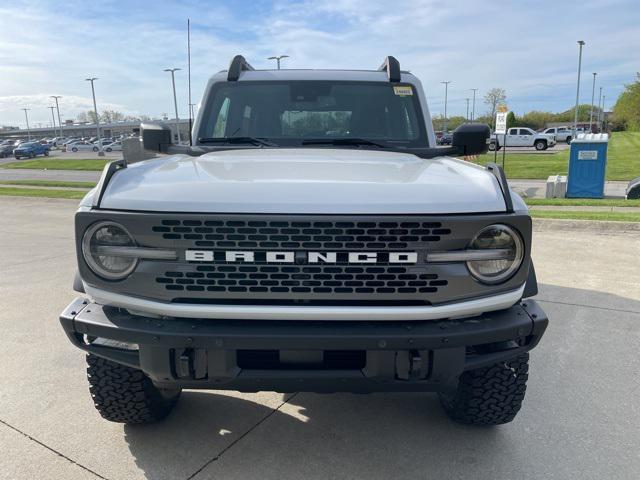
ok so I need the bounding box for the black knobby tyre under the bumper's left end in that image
[87,354,181,424]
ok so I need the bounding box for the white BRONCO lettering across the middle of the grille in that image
[185,250,418,264]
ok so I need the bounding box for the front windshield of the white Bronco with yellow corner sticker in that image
[198,81,429,148]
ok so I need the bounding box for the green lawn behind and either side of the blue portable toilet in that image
[478,132,640,180]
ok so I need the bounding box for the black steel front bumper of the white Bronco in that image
[60,298,548,392]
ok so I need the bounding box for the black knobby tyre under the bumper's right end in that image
[439,353,529,425]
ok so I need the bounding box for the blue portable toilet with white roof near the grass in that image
[567,133,609,198]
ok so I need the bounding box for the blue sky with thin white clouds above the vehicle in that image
[0,0,640,128]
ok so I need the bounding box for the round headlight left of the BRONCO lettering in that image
[82,222,138,280]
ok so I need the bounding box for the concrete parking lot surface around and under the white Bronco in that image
[0,198,640,480]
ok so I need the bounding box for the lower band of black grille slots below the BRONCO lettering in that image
[156,265,447,294]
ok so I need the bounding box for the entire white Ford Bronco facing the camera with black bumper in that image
[60,56,548,425]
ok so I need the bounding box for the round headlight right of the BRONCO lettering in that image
[467,224,524,284]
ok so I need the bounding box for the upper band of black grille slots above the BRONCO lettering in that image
[152,219,451,251]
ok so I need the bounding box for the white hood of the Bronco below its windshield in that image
[100,148,505,214]
